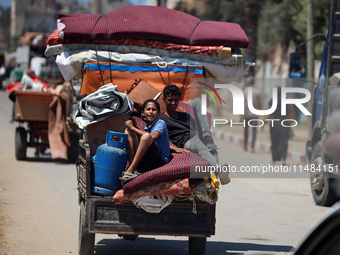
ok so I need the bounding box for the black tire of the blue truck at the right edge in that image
[310,141,337,206]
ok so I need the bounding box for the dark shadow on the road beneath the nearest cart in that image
[95,237,293,255]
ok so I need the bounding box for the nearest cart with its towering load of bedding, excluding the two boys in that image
[45,6,249,255]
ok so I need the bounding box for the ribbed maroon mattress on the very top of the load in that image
[54,6,249,48]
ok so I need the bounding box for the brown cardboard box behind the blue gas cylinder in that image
[85,115,130,154]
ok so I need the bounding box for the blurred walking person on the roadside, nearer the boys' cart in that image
[243,76,262,152]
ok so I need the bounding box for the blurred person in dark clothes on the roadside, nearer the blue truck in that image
[268,87,294,165]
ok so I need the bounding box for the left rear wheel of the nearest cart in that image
[78,201,95,255]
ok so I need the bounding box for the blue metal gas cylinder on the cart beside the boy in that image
[93,131,128,196]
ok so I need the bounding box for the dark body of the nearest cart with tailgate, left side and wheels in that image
[77,118,216,255]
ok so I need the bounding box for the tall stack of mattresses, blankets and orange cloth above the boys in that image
[45,6,249,99]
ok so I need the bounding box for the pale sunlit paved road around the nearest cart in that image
[0,91,327,255]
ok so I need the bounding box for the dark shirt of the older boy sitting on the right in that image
[160,112,195,148]
